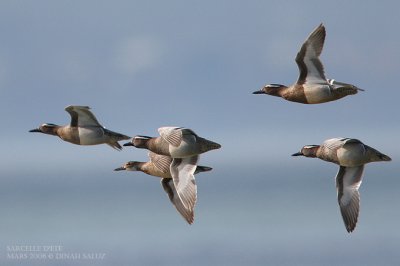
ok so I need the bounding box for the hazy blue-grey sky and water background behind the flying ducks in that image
[0,0,400,265]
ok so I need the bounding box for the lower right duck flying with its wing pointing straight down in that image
[292,138,392,233]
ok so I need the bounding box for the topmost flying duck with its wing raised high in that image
[253,23,363,104]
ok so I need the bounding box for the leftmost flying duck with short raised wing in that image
[29,105,130,150]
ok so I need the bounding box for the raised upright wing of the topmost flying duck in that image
[296,23,327,85]
